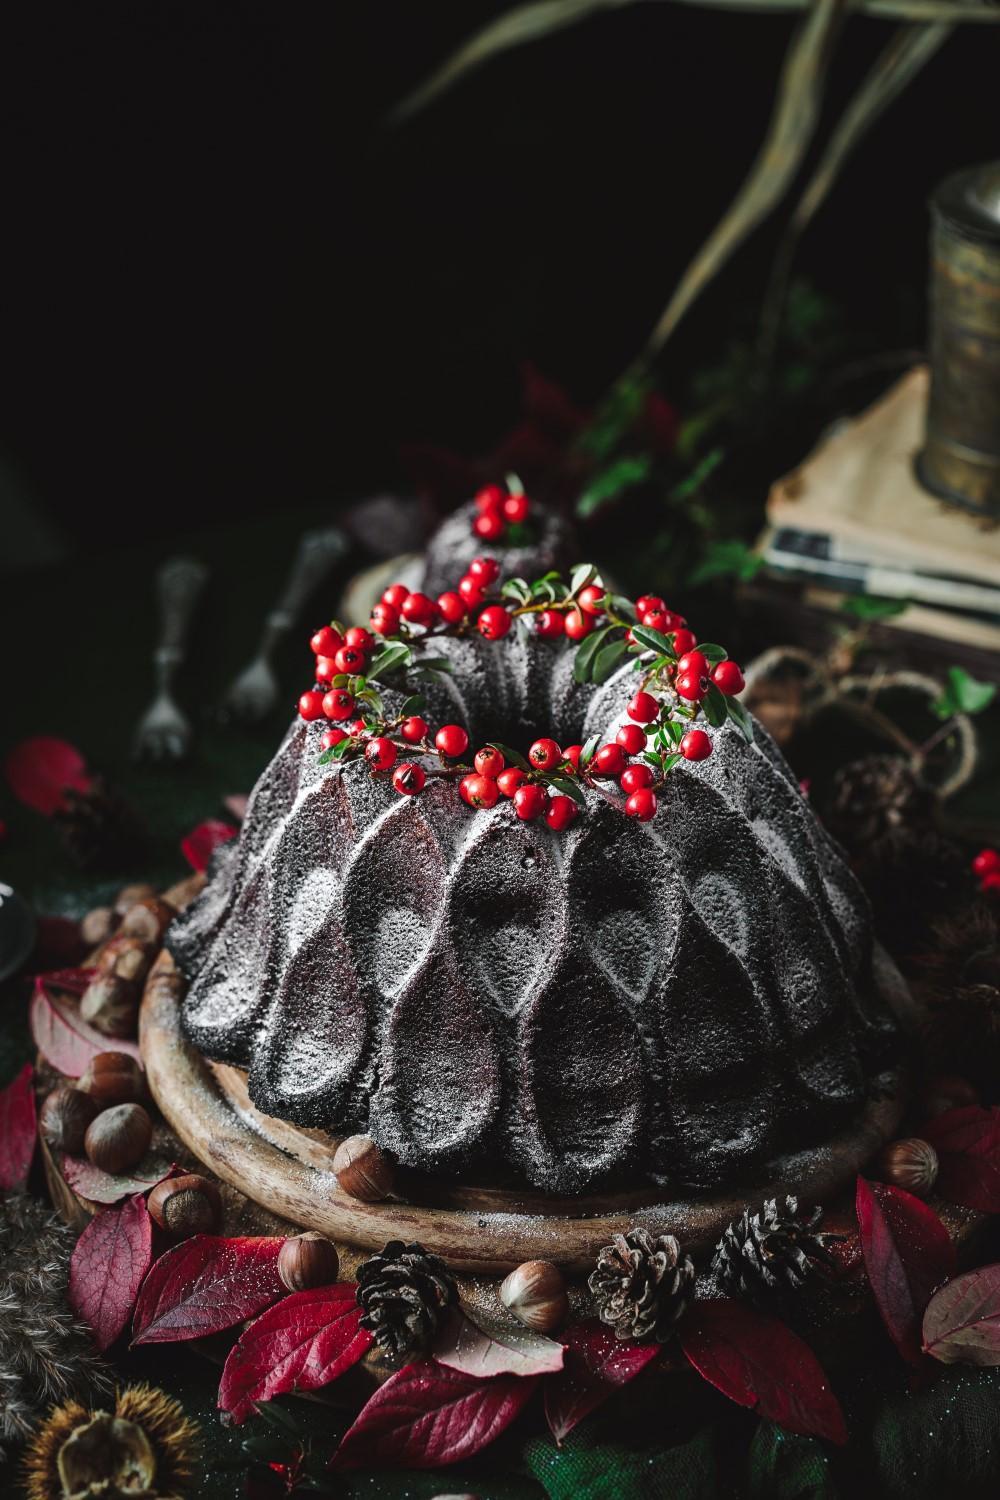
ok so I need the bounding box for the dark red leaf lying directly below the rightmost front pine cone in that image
[681,1299,847,1443]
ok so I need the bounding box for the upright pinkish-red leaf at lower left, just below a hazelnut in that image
[69,1194,153,1350]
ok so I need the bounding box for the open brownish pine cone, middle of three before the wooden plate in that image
[588,1229,694,1343]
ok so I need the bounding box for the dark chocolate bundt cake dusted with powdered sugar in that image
[168,516,895,1193]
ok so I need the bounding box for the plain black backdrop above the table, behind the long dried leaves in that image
[0,0,1000,561]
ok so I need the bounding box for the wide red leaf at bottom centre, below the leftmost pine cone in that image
[331,1359,538,1469]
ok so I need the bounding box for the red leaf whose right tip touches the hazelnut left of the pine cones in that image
[132,1235,285,1344]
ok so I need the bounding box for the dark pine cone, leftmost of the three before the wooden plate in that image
[357,1239,457,1359]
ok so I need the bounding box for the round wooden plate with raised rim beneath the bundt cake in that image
[139,951,909,1275]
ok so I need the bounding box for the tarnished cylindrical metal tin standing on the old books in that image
[918,162,1000,519]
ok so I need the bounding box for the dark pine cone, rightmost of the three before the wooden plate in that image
[712,1197,841,1302]
